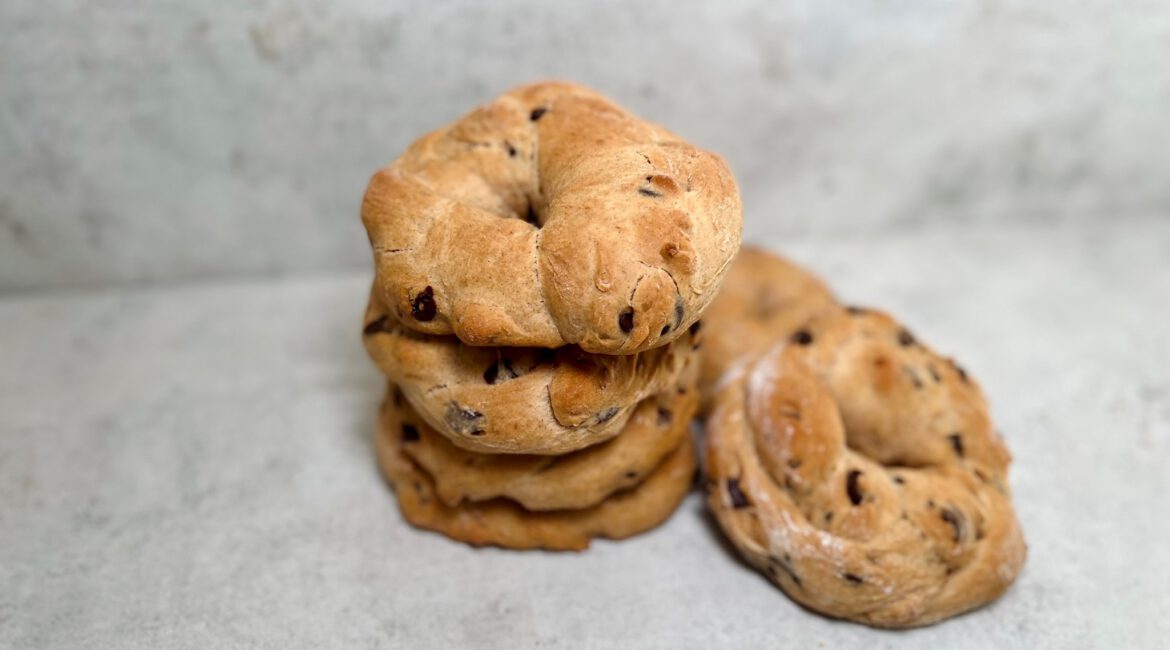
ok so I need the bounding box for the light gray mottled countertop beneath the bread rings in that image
[0,217,1170,650]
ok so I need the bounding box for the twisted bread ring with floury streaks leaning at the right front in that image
[707,310,1026,628]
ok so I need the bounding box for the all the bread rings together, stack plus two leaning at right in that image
[362,78,1026,628]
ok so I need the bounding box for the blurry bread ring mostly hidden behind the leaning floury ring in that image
[698,247,837,412]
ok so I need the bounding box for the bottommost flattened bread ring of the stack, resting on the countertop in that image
[374,388,695,551]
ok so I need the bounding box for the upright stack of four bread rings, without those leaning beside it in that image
[362,83,742,549]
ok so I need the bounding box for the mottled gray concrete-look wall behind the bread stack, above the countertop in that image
[0,0,1170,291]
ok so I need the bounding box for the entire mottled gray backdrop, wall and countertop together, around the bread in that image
[0,0,1170,650]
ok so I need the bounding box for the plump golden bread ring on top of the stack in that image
[362,83,743,354]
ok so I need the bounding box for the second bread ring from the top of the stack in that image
[363,286,701,455]
